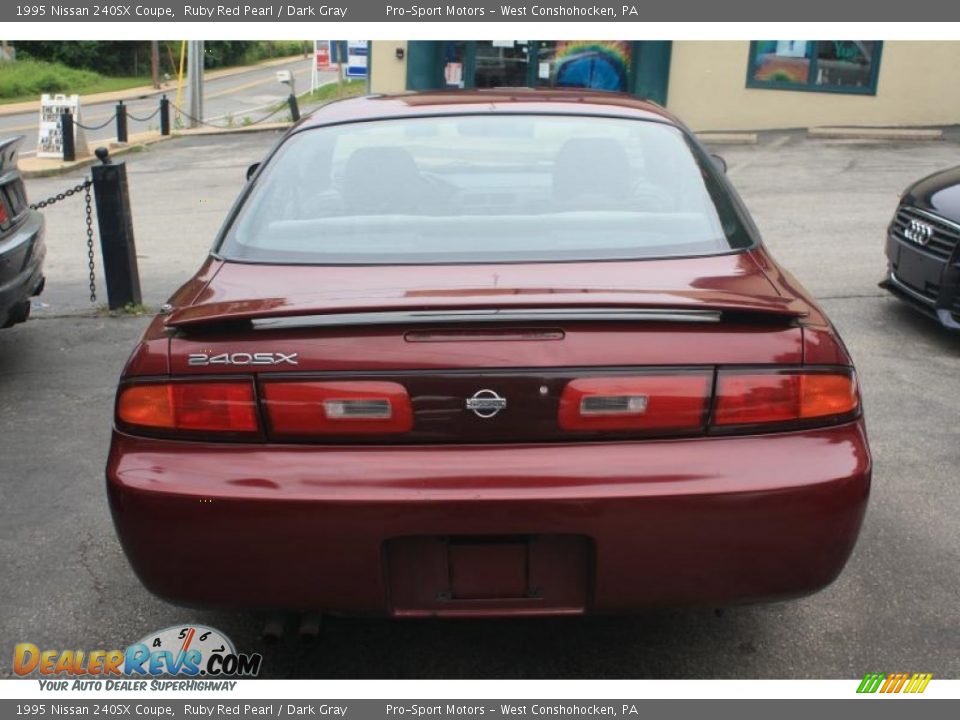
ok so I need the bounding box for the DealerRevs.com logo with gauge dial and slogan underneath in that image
[13,625,263,690]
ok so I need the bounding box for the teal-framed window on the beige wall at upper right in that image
[747,40,883,95]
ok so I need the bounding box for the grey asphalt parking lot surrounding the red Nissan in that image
[0,133,960,678]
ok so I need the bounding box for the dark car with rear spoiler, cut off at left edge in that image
[0,137,47,327]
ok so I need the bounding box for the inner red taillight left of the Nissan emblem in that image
[262,380,413,437]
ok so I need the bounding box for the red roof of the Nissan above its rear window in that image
[298,88,682,129]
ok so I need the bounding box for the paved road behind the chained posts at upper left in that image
[0,59,326,155]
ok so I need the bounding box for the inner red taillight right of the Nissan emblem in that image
[559,372,713,431]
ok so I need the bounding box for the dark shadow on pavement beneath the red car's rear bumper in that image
[188,604,787,679]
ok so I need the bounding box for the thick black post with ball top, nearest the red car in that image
[90,148,142,310]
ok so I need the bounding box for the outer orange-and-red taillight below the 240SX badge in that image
[117,380,259,434]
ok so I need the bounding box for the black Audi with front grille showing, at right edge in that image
[880,167,960,330]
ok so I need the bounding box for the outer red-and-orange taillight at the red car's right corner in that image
[713,370,860,426]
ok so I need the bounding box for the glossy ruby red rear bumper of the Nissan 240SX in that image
[107,421,871,616]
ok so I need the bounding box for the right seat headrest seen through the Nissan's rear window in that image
[553,138,631,202]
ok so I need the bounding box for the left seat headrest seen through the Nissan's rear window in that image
[342,146,424,213]
